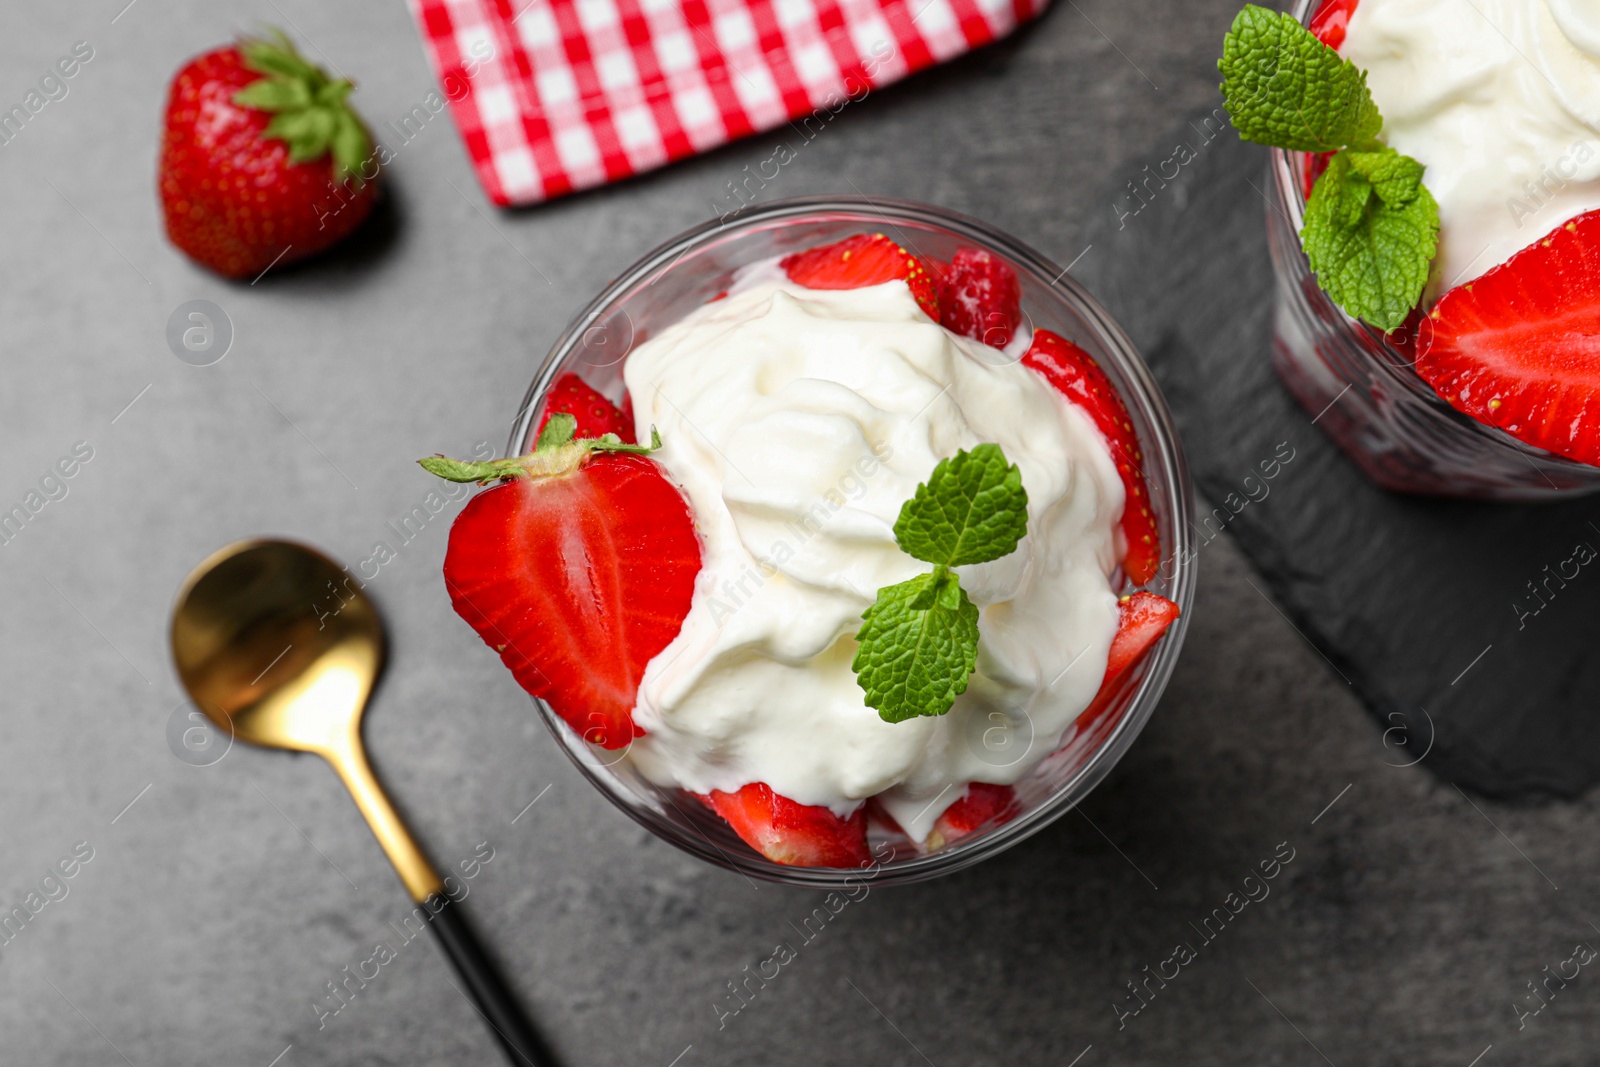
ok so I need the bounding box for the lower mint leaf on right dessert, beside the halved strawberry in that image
[1301,149,1438,330]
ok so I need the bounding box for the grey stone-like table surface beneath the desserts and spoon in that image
[0,0,1600,1067]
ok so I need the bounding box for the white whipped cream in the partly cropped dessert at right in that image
[1339,0,1600,296]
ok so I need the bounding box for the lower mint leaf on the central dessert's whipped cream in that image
[851,566,978,723]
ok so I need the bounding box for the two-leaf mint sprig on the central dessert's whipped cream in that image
[851,445,1027,723]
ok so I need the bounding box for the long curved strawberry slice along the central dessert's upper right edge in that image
[1022,330,1162,585]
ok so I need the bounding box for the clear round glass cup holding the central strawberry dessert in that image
[509,198,1195,888]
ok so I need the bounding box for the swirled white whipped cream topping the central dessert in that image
[626,270,1123,840]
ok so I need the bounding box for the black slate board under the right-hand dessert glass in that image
[1074,118,1600,798]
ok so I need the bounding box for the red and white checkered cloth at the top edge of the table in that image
[411,0,1050,205]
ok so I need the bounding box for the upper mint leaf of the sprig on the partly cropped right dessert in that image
[1218,5,1384,152]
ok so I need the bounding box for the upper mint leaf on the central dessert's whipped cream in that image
[894,445,1027,566]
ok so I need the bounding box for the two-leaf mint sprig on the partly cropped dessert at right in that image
[1218,5,1438,330]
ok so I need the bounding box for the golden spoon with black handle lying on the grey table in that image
[171,541,552,1067]
